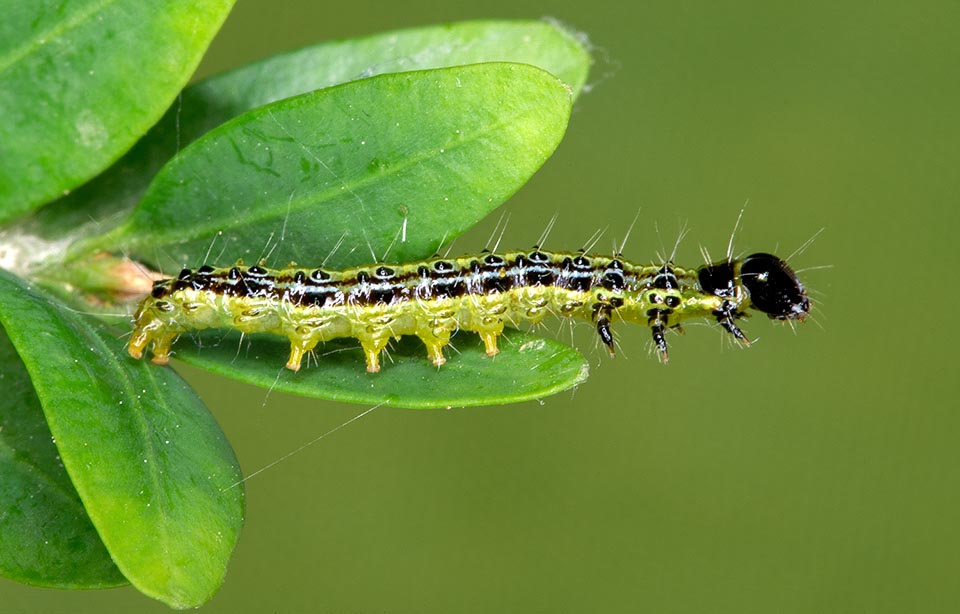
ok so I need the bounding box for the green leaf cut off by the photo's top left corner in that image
[0,0,233,221]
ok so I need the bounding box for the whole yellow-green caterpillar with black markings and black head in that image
[128,248,810,373]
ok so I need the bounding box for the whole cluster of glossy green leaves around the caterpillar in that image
[0,6,590,608]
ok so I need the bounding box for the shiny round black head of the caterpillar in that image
[740,253,810,320]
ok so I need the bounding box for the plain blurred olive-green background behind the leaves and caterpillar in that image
[7,0,960,614]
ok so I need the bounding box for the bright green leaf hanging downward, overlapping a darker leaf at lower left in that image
[0,271,243,607]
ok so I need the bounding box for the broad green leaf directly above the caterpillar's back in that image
[92,64,570,270]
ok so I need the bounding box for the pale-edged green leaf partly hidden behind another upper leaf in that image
[35,21,591,241]
